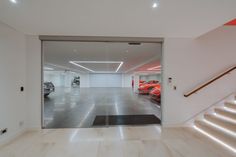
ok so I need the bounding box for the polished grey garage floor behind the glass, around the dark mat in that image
[44,87,161,128]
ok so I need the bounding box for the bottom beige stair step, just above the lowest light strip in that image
[194,120,236,148]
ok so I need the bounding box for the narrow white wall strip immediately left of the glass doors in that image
[26,35,41,128]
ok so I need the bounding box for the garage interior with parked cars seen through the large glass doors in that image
[42,41,162,128]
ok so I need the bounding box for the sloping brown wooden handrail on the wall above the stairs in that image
[184,66,236,97]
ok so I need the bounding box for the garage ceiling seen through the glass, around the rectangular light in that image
[43,41,162,73]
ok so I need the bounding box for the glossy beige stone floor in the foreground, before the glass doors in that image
[0,125,235,157]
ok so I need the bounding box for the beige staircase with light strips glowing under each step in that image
[194,101,236,153]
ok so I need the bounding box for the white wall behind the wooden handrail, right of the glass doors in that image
[162,27,236,125]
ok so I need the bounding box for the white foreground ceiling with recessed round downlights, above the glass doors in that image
[0,0,236,37]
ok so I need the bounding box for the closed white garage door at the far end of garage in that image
[89,74,122,87]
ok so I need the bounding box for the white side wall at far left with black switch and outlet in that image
[0,22,27,144]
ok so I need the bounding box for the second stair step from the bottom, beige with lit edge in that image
[204,114,236,133]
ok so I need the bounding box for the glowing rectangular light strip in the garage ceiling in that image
[69,61,124,73]
